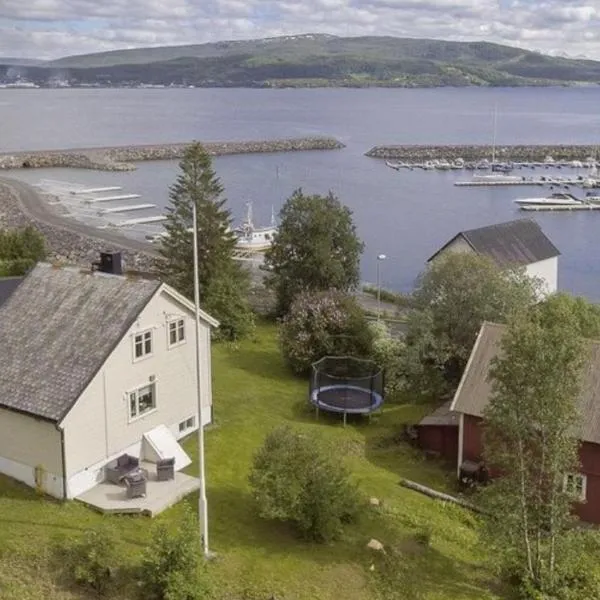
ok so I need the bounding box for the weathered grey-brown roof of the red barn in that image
[452,323,600,444]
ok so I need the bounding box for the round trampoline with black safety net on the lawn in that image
[310,356,383,424]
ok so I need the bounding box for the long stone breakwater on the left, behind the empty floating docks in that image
[0,137,344,171]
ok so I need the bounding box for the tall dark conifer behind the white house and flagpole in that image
[157,143,253,339]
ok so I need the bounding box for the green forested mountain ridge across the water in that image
[10,34,600,87]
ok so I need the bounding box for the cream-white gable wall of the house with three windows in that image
[62,292,212,498]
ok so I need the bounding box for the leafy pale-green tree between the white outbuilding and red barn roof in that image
[404,252,539,395]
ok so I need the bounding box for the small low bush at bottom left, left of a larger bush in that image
[65,529,118,595]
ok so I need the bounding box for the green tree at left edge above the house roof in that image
[0,226,46,277]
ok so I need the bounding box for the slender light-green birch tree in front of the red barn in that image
[484,309,586,597]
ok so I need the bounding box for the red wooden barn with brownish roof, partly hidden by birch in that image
[451,323,600,523]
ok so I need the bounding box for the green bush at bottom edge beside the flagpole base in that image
[141,509,208,600]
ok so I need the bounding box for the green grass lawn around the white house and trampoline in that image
[0,326,501,600]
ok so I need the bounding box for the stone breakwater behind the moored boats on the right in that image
[366,144,597,163]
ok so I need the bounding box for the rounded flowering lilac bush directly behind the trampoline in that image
[279,290,373,375]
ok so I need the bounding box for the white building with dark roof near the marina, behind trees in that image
[427,219,560,296]
